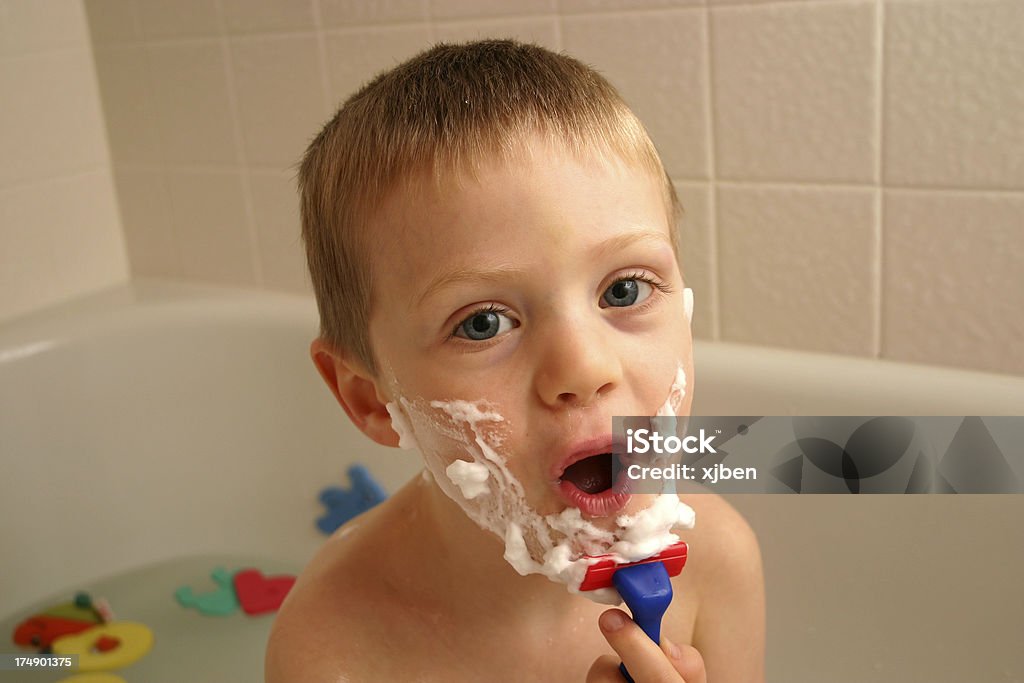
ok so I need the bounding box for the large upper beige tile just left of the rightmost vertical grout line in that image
[712,2,879,182]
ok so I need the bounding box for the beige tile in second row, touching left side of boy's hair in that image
[230,34,325,168]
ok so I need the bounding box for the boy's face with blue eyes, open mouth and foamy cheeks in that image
[370,136,693,565]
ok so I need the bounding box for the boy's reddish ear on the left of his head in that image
[309,337,398,446]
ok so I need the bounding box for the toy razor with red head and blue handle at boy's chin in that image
[580,541,688,683]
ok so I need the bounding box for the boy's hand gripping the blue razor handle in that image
[587,609,708,683]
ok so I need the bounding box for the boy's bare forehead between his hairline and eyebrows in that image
[372,160,674,286]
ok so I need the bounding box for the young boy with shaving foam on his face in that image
[266,41,764,683]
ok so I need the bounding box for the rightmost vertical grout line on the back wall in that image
[871,0,886,358]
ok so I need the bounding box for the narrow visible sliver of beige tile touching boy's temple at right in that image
[676,182,717,339]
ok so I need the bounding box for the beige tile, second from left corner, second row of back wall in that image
[148,41,238,164]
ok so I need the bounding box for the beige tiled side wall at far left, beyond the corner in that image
[0,0,128,321]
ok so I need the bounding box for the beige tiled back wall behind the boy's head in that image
[75,0,1024,374]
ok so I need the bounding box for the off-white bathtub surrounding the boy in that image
[0,281,1024,683]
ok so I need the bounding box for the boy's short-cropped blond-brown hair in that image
[298,40,682,376]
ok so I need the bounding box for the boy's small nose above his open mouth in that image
[536,315,623,408]
